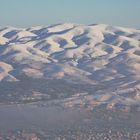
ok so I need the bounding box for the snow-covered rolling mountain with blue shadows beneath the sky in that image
[0,23,140,109]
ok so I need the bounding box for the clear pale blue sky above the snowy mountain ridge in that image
[0,0,140,28]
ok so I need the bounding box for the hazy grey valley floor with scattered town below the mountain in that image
[0,103,140,140]
